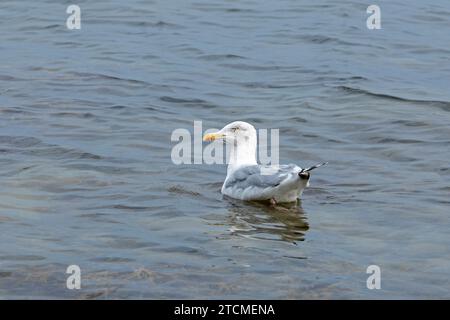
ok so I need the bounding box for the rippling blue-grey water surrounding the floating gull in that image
[0,0,450,299]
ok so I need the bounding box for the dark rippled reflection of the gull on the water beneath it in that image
[225,200,309,243]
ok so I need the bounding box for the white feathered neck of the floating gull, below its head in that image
[227,137,257,175]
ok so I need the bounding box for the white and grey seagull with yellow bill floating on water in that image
[203,121,327,205]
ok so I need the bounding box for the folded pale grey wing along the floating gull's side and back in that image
[225,165,296,189]
